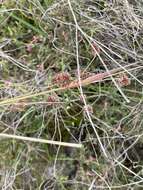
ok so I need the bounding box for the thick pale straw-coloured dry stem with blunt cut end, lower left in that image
[0,133,82,148]
